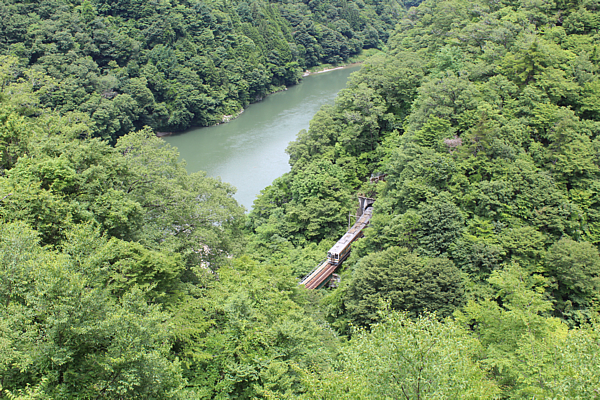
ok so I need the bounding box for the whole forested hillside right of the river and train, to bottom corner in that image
[250,0,600,399]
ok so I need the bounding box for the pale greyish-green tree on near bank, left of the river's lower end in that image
[115,129,243,266]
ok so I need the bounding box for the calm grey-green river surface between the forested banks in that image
[164,66,360,209]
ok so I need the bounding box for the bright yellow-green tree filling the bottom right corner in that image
[458,264,598,398]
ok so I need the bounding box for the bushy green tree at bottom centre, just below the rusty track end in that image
[171,257,335,398]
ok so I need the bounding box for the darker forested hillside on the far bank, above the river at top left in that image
[0,0,403,141]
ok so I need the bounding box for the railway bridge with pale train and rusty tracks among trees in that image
[300,195,375,289]
